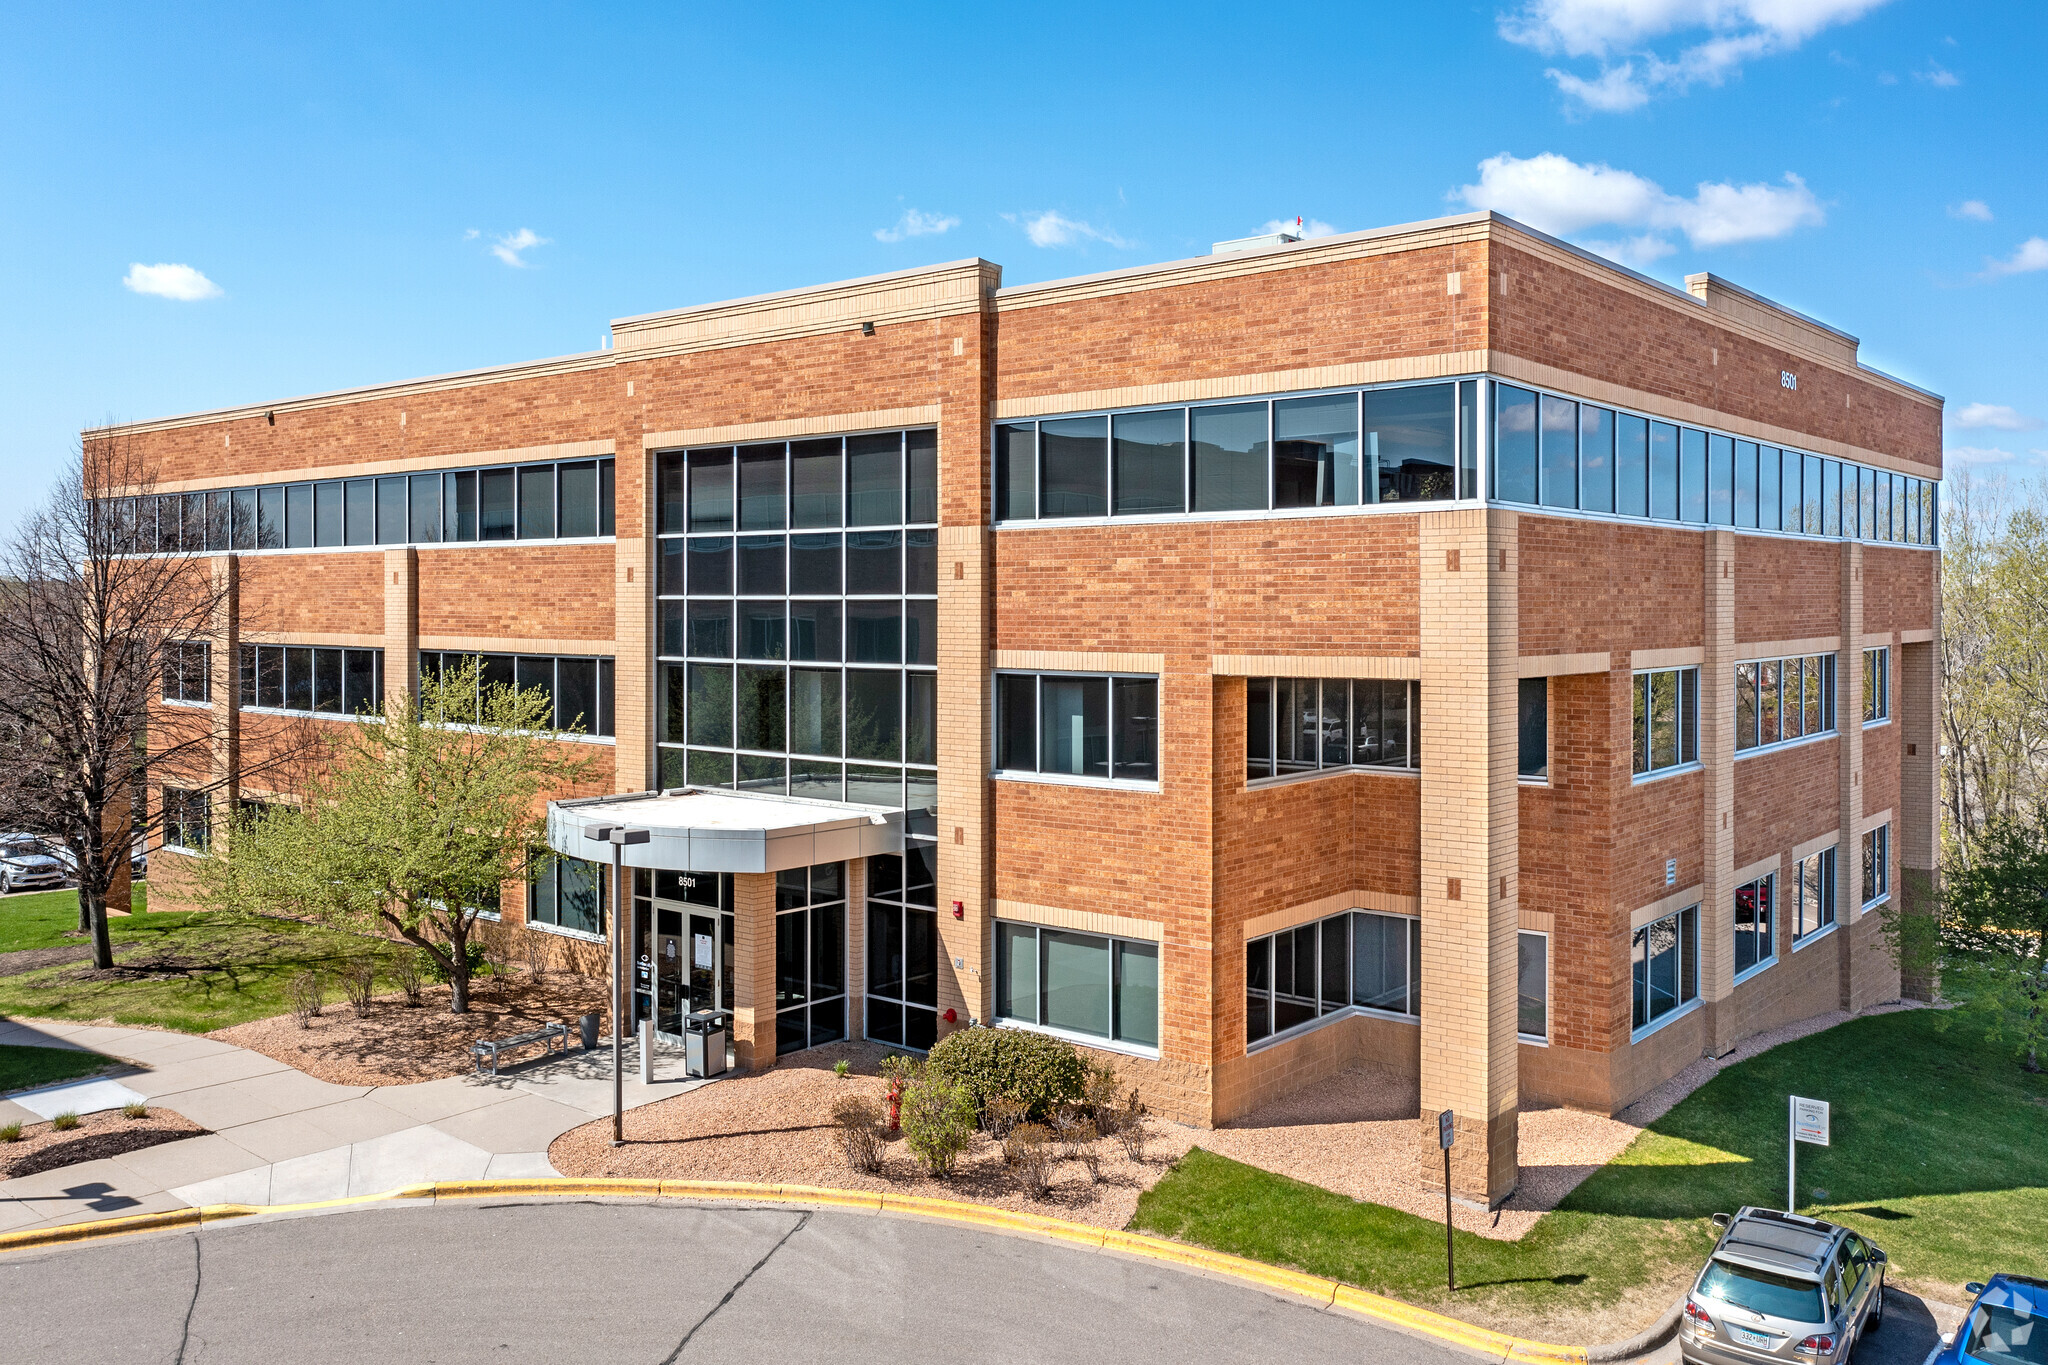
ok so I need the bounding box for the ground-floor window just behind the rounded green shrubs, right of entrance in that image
[995,921,1159,1048]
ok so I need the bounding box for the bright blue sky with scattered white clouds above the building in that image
[0,0,2048,524]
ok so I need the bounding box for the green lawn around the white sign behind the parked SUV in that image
[1133,1011,2048,1320]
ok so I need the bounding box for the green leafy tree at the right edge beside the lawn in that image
[1942,800,2048,1072]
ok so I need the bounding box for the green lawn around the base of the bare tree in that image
[0,892,403,1033]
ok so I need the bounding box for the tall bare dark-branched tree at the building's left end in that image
[0,432,295,968]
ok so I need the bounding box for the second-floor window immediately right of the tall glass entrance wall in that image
[995,673,1159,782]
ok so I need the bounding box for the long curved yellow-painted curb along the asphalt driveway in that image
[0,1179,1589,1365]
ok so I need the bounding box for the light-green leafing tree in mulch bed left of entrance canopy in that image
[199,659,596,1013]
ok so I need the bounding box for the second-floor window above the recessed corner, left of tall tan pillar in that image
[1245,677,1421,782]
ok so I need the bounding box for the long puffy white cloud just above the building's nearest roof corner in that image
[1456,151,1827,264]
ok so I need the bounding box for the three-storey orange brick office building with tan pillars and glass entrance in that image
[112,213,1942,1199]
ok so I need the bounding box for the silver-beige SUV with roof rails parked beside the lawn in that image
[1677,1205,1884,1365]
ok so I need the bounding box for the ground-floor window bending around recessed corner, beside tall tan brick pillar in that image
[1245,911,1421,1048]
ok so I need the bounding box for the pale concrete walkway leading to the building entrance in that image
[0,1019,711,1232]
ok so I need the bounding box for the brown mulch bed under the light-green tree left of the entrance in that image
[219,970,606,1085]
